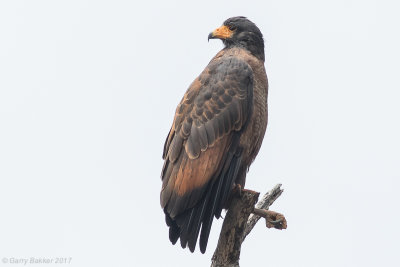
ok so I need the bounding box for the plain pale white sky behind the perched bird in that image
[0,0,400,267]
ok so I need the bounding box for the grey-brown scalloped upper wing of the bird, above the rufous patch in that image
[164,51,253,159]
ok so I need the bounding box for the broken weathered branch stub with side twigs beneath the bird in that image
[211,184,286,267]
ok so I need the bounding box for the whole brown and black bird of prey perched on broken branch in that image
[160,17,268,253]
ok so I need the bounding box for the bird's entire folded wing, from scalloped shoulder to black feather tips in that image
[160,57,253,253]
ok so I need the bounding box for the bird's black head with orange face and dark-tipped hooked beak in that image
[208,17,265,61]
